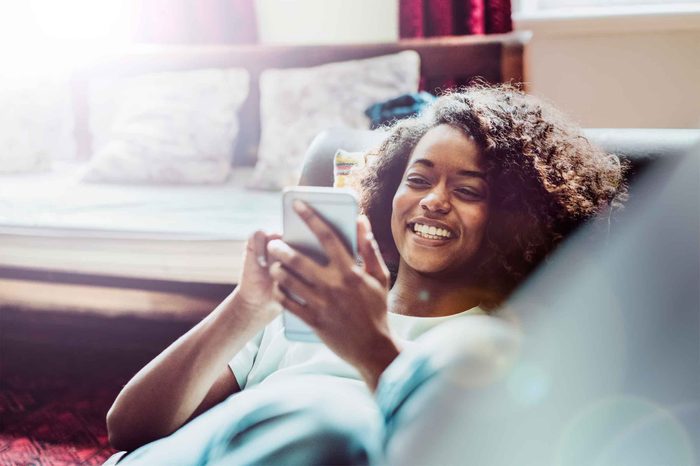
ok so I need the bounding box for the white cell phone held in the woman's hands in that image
[282,186,358,343]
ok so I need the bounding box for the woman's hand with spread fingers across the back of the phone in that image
[268,202,399,389]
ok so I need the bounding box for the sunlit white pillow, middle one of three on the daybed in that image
[83,68,249,183]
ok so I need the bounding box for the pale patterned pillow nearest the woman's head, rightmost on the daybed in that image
[251,51,420,189]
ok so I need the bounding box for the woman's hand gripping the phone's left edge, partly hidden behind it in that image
[234,230,282,325]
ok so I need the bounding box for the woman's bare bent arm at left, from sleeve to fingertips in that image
[107,232,281,450]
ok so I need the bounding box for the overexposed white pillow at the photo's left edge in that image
[0,76,75,174]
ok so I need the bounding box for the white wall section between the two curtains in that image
[256,0,399,44]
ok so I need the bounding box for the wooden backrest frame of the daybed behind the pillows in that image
[72,32,530,165]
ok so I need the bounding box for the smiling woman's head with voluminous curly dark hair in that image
[356,85,626,308]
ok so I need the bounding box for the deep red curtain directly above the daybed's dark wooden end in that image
[399,0,513,39]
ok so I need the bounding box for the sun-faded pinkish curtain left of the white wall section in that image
[134,0,257,44]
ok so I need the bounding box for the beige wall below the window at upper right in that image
[516,16,700,128]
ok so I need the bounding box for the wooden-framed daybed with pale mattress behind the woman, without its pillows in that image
[0,32,529,322]
